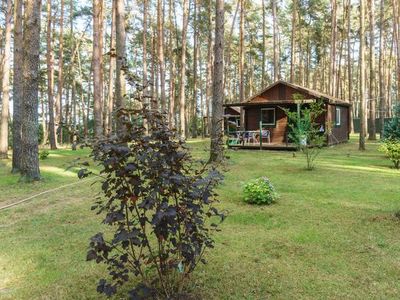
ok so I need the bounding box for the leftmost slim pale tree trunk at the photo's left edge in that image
[0,0,13,159]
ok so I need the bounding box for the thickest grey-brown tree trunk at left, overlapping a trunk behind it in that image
[21,1,41,182]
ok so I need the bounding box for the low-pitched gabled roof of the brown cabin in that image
[225,80,351,106]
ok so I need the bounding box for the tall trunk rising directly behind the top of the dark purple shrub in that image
[115,0,126,136]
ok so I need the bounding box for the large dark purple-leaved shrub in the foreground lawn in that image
[78,108,224,299]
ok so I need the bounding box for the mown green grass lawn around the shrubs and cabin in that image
[0,140,400,299]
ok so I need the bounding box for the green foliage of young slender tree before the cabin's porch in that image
[282,101,326,170]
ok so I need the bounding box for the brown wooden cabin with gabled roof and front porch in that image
[225,80,350,149]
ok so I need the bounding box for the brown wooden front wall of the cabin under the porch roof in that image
[245,106,288,144]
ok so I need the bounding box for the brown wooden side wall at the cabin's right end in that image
[327,104,349,145]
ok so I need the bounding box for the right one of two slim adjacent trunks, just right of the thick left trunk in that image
[56,0,64,144]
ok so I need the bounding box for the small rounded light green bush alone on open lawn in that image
[243,177,278,205]
